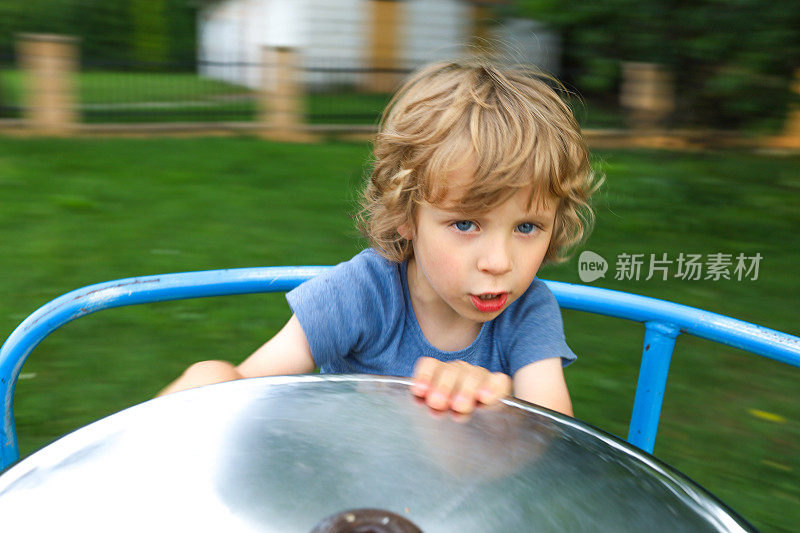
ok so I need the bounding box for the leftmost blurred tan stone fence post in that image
[17,34,78,136]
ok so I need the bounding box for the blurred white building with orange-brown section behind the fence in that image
[198,0,559,87]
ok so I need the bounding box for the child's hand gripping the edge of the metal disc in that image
[411,357,511,413]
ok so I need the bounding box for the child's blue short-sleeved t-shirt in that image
[286,248,575,377]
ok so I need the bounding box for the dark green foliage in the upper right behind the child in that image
[517,0,800,129]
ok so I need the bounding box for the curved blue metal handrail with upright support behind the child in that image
[0,266,800,470]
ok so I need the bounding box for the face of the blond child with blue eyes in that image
[399,162,555,322]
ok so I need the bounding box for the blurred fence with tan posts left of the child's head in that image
[0,35,411,134]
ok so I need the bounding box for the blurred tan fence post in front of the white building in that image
[259,46,312,142]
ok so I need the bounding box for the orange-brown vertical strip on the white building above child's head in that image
[364,0,402,93]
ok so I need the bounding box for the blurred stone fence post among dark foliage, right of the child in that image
[620,62,675,129]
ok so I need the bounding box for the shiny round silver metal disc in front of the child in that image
[0,376,751,533]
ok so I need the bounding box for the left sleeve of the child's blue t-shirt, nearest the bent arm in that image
[286,249,402,367]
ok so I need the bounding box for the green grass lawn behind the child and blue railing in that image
[0,138,800,531]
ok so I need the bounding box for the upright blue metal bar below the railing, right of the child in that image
[628,321,680,453]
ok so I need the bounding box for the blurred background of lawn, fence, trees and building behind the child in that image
[0,0,800,531]
